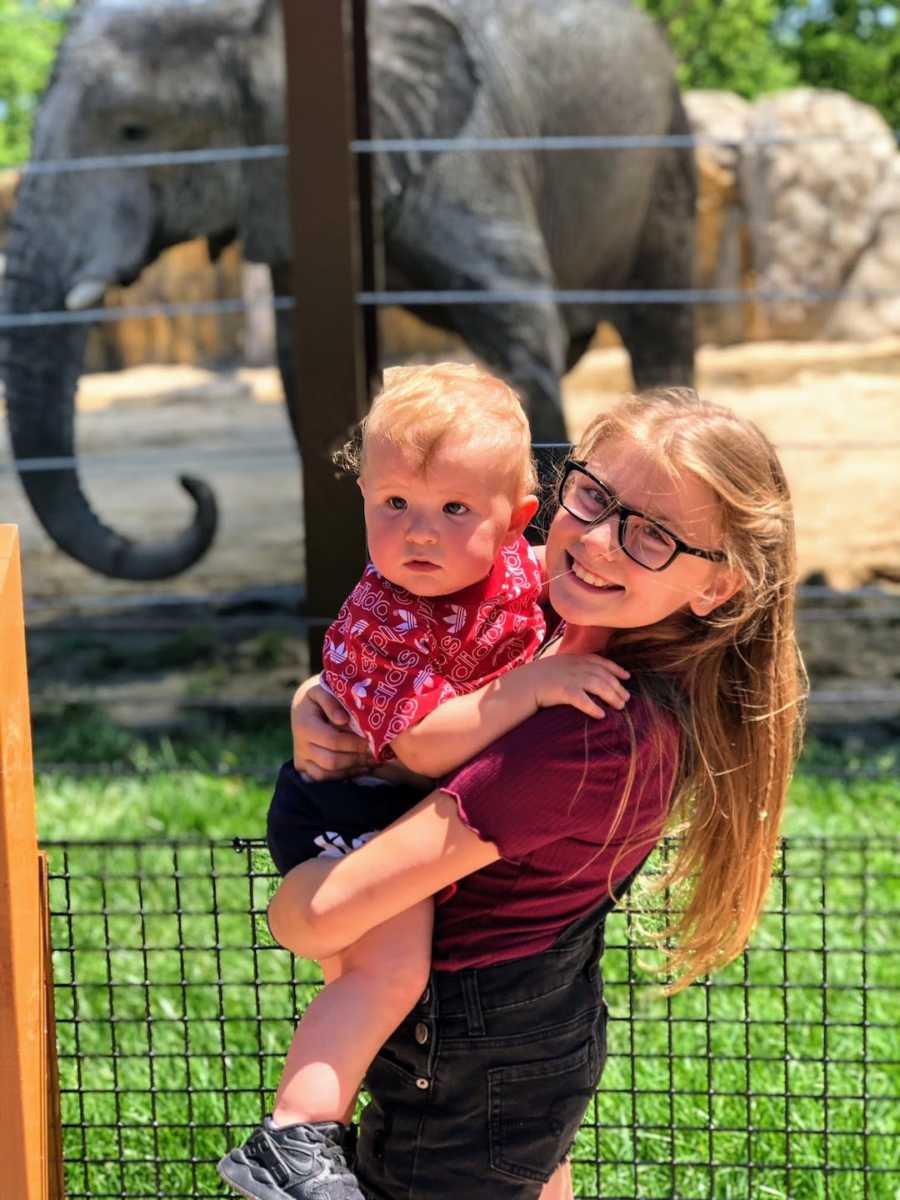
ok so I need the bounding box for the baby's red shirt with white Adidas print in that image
[322,538,546,762]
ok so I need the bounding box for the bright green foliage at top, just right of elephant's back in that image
[637,0,799,98]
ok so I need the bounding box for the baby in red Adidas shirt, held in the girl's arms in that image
[220,364,628,1200]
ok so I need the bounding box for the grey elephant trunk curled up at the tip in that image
[0,227,217,581]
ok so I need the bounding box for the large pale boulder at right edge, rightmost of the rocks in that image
[739,88,896,338]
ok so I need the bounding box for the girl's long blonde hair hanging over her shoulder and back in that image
[575,388,805,992]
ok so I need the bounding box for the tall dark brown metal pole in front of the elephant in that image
[282,0,368,670]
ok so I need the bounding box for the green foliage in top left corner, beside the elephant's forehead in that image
[0,0,72,167]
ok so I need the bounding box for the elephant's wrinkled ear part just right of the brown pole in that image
[368,0,481,199]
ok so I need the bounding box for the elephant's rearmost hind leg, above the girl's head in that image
[612,103,697,389]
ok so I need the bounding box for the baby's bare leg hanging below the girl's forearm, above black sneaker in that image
[272,900,434,1126]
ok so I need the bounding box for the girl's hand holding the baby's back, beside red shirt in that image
[290,677,373,780]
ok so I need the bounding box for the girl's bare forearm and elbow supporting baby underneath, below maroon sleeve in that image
[269,791,500,959]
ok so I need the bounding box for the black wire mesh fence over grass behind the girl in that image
[47,838,900,1200]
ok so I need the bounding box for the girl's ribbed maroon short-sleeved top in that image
[433,697,678,971]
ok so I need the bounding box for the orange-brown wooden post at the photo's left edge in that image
[0,526,52,1200]
